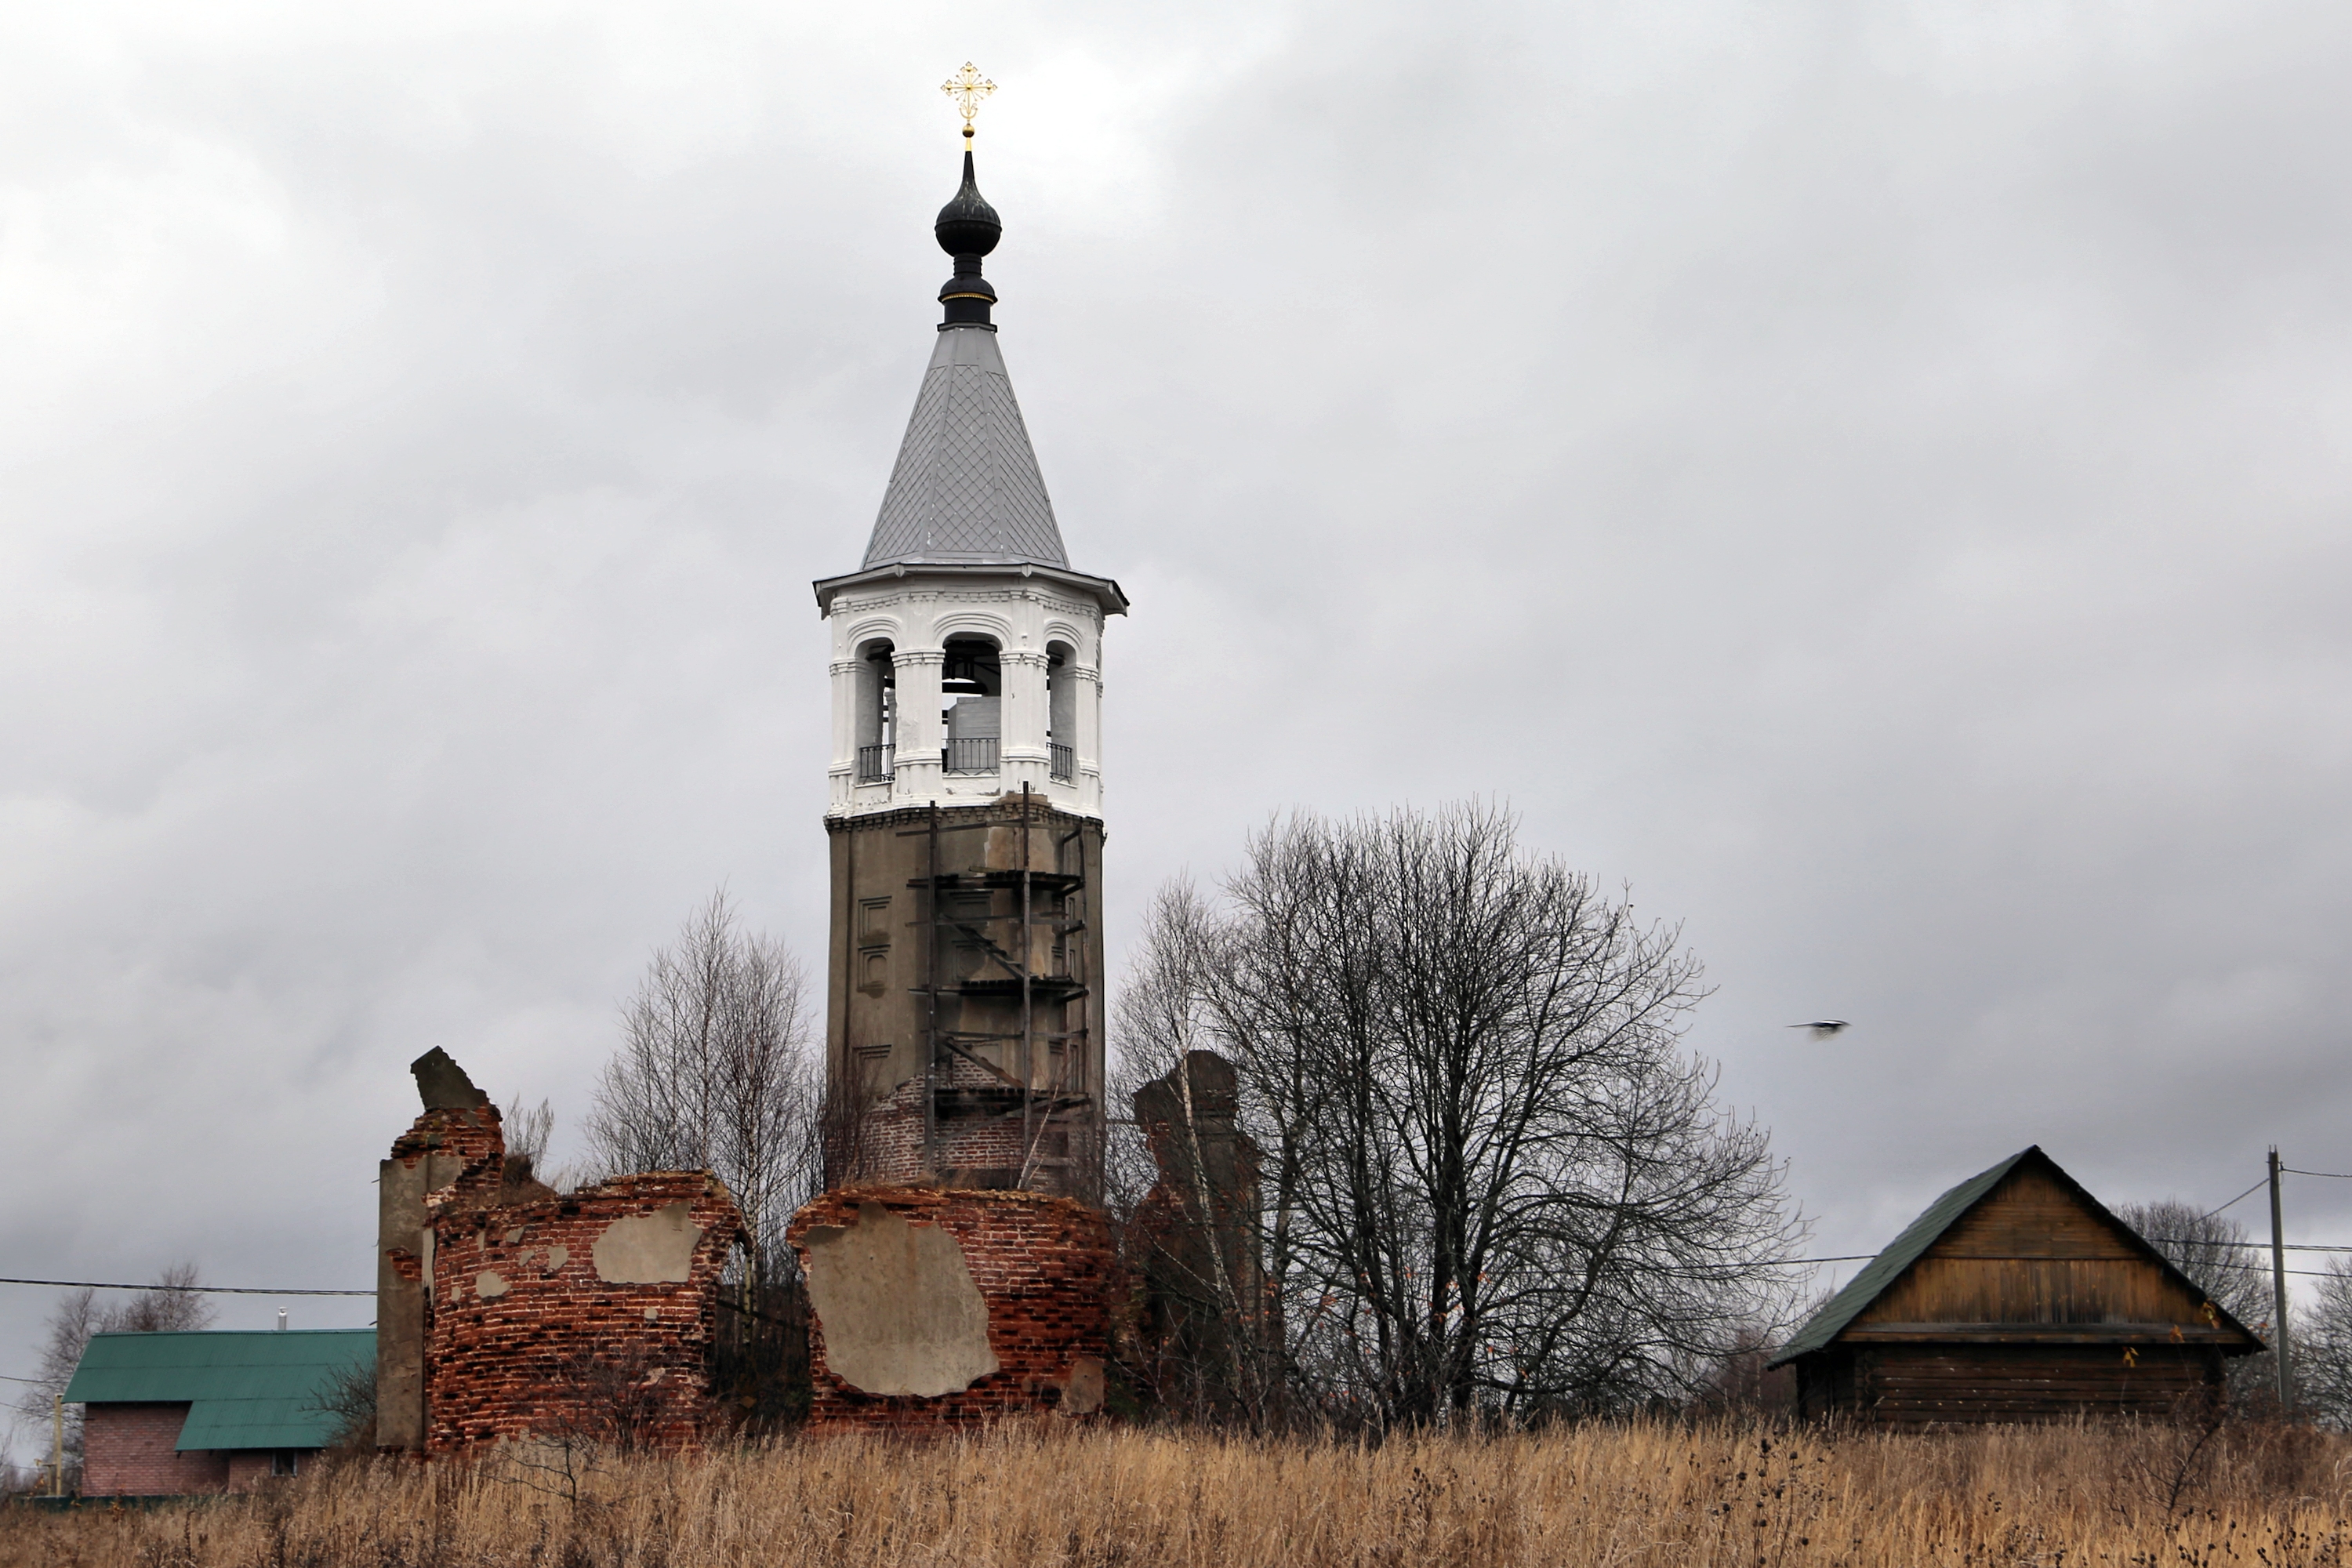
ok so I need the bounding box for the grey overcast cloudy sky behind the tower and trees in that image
[0,0,2352,1448]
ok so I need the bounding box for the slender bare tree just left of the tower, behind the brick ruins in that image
[586,891,821,1305]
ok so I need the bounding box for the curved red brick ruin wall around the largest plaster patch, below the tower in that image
[790,1187,1124,1429]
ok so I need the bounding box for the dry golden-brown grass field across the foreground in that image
[0,1425,2352,1568]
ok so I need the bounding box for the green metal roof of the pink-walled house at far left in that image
[66,1328,376,1450]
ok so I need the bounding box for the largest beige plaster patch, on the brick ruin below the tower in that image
[807,1203,997,1399]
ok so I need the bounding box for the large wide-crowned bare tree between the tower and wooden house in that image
[1120,806,1802,1425]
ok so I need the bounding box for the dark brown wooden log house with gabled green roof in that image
[1771,1147,2263,1427]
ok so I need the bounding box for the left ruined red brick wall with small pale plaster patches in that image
[426,1171,743,1453]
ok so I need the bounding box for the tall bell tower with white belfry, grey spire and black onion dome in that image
[816,131,1127,1201]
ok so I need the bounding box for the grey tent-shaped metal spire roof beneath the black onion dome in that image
[866,325,1070,569]
